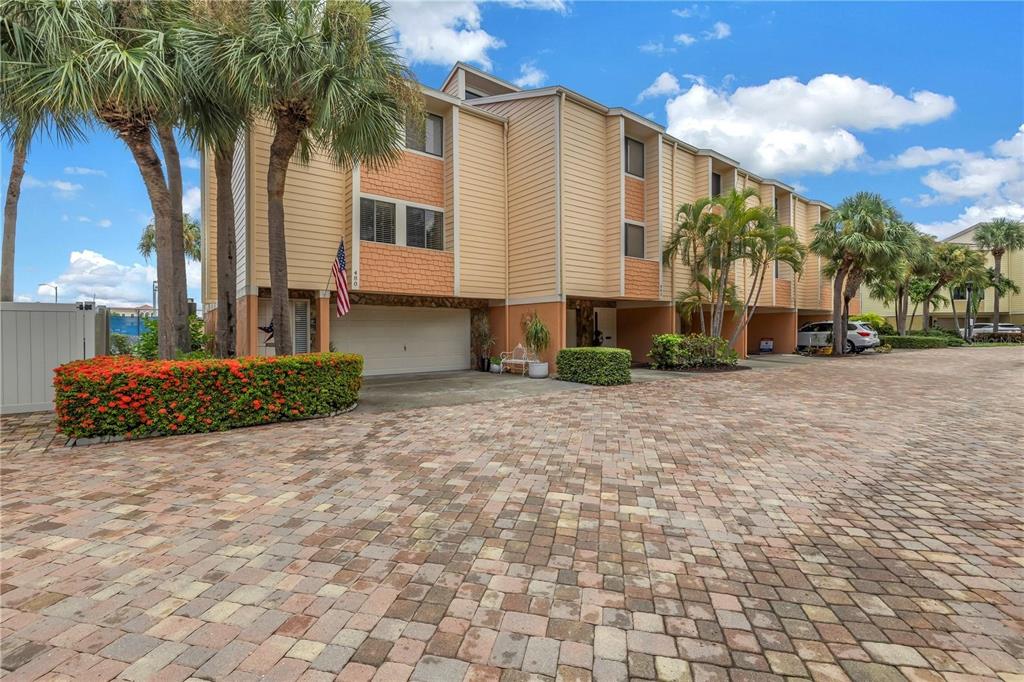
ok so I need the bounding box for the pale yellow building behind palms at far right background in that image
[861,223,1024,329]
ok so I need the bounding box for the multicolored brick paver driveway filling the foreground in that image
[0,348,1024,681]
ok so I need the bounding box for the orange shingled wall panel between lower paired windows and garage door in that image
[359,242,455,296]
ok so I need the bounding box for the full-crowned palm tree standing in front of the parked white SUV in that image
[810,191,905,355]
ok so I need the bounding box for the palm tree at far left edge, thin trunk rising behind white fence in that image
[0,3,84,301]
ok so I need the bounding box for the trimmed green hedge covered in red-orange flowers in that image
[53,353,362,439]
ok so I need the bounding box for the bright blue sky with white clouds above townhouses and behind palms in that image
[2,0,1024,302]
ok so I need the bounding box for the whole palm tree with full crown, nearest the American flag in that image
[205,0,422,355]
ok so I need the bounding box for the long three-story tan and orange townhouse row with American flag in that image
[203,63,831,374]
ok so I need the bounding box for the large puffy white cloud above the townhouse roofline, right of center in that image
[666,74,955,175]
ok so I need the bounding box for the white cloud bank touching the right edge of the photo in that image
[909,125,1024,237]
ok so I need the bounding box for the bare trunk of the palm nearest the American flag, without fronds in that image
[266,112,301,355]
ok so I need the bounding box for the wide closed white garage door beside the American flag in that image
[331,305,469,376]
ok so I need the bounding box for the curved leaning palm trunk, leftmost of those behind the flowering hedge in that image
[109,112,181,359]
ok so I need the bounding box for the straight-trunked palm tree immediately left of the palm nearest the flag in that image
[176,0,253,357]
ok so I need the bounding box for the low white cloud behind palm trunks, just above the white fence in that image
[36,249,201,307]
